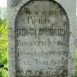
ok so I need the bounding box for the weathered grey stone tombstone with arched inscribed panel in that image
[8,0,76,77]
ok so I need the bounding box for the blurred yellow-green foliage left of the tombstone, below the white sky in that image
[0,8,8,77]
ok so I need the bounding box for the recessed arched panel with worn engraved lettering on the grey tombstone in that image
[15,0,69,77]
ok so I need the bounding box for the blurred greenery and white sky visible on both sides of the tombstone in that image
[0,0,77,77]
